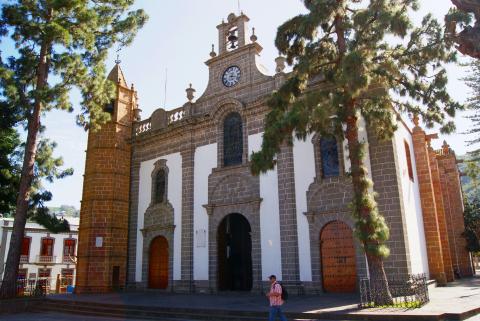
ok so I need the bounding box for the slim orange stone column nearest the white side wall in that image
[412,124,447,285]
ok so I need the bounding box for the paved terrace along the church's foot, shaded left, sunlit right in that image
[49,275,480,315]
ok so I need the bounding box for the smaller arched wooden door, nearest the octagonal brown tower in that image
[148,236,168,289]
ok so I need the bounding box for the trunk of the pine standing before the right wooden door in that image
[346,100,393,305]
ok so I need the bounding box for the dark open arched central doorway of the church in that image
[217,214,252,291]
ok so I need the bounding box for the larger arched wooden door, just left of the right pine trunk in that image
[320,221,357,293]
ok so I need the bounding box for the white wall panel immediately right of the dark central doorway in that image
[248,133,282,280]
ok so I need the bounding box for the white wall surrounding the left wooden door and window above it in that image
[135,153,182,282]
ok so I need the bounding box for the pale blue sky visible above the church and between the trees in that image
[2,0,470,208]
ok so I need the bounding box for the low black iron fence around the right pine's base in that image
[359,274,430,308]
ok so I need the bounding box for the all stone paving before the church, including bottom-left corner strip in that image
[0,276,480,321]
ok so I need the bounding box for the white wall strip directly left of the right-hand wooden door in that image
[293,135,316,281]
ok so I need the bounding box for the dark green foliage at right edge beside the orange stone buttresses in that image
[463,195,480,253]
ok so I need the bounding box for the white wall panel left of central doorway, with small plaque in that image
[193,144,217,280]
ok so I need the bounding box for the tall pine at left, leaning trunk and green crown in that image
[0,0,146,298]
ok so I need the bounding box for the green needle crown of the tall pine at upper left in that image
[0,0,147,129]
